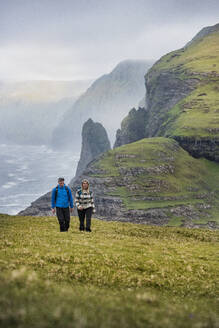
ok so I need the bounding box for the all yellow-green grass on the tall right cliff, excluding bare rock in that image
[149,31,219,139]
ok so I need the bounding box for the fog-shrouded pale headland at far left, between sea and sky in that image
[0,80,91,145]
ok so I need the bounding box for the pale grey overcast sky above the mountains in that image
[0,0,219,80]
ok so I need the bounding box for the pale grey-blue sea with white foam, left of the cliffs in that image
[0,144,79,214]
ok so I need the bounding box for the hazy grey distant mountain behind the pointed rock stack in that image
[53,60,152,151]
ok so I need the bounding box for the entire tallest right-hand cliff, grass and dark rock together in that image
[145,24,219,161]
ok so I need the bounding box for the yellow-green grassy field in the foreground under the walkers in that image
[0,215,219,328]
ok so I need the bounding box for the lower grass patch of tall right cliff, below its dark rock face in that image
[160,82,219,139]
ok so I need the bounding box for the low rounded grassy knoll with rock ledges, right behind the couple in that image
[95,137,219,223]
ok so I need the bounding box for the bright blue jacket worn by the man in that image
[51,185,73,208]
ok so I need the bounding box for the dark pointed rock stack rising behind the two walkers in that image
[76,119,111,177]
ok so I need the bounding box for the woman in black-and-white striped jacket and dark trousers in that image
[75,179,95,232]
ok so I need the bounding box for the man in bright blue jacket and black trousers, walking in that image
[51,178,73,231]
